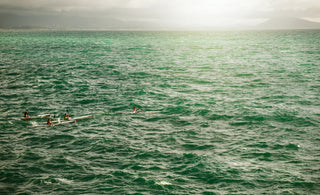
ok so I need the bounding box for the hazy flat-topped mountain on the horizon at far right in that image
[255,18,320,30]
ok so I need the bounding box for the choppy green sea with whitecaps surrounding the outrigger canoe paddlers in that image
[0,31,320,194]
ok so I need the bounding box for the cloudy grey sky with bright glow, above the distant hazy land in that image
[0,0,320,29]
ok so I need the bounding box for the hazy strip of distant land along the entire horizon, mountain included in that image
[0,14,320,31]
